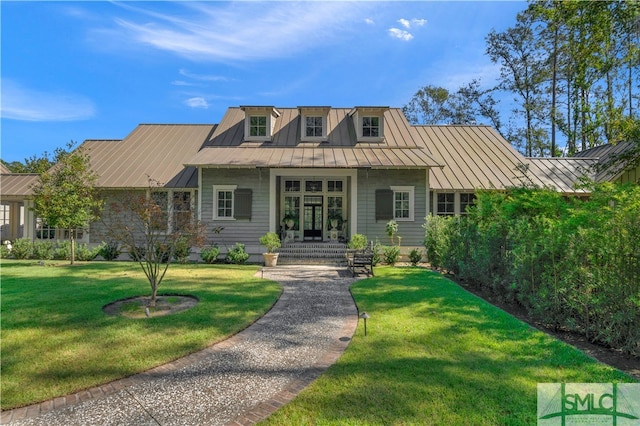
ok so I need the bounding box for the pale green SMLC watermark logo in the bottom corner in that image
[538,383,640,426]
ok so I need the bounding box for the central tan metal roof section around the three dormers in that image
[185,108,440,168]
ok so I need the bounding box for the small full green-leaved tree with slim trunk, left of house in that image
[33,142,104,265]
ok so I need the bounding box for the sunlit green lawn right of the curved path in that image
[264,267,636,425]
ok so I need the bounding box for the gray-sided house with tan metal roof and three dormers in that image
[1,106,637,260]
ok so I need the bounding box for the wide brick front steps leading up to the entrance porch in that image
[278,241,347,266]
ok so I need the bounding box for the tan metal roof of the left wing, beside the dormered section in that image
[82,124,215,188]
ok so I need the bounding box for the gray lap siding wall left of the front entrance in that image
[201,169,269,254]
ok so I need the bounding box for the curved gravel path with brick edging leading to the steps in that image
[2,266,358,426]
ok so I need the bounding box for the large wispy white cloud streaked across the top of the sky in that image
[102,2,362,61]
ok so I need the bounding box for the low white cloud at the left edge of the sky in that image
[0,79,95,121]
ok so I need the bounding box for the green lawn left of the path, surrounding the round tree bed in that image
[0,259,281,409]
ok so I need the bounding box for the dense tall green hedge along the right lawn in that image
[425,183,640,356]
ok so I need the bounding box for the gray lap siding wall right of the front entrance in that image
[358,170,427,247]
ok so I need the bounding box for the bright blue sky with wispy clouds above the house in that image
[0,1,526,161]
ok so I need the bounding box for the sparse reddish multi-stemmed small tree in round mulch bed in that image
[105,179,205,307]
